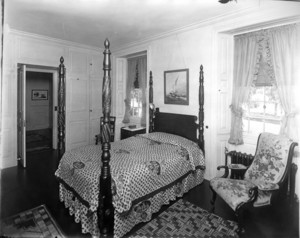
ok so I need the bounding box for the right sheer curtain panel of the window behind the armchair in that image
[267,24,300,141]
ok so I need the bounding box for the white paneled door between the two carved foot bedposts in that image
[66,49,103,150]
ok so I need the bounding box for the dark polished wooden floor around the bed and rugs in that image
[0,151,299,238]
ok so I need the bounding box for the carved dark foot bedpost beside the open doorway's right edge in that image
[57,57,66,159]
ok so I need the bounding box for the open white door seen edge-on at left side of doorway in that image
[18,65,26,168]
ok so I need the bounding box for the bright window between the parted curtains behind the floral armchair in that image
[243,50,284,136]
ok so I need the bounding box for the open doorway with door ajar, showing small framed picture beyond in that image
[18,64,58,167]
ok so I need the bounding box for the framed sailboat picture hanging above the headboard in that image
[164,69,189,105]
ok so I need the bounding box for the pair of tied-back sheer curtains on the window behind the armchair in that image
[228,24,300,145]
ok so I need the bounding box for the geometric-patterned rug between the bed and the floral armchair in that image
[130,199,238,238]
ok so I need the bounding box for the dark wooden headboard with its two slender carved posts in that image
[149,65,205,153]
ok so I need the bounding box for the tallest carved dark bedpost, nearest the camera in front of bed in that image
[97,39,114,237]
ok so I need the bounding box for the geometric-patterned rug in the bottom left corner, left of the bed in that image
[0,205,64,238]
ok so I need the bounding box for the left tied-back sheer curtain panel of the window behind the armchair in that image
[228,33,261,145]
